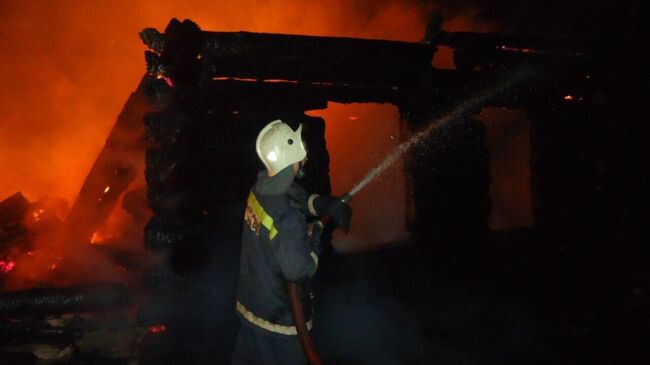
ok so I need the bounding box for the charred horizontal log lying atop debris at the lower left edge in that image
[0,284,130,317]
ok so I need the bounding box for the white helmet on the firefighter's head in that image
[255,119,307,176]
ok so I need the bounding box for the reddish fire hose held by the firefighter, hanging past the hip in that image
[287,193,352,365]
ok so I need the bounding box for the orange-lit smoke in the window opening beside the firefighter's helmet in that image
[309,103,407,251]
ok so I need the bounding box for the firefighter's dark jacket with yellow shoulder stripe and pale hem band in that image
[236,166,320,335]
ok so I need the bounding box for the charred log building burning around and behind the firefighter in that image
[0,1,643,363]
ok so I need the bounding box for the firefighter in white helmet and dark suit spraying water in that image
[232,120,352,365]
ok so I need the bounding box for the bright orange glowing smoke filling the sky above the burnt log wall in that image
[0,0,426,201]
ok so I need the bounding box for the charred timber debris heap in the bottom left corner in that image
[0,283,136,361]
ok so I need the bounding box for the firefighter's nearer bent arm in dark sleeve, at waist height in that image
[275,210,320,282]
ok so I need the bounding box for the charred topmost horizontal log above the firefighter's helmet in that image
[141,19,434,86]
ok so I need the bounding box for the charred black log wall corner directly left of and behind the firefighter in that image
[138,21,330,363]
